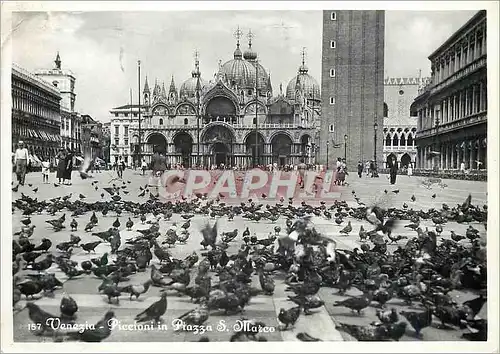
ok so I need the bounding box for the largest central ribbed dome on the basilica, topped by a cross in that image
[220,44,260,89]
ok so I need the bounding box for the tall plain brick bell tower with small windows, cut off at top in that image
[320,10,385,169]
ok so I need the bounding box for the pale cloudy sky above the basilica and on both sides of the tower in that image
[10,10,477,122]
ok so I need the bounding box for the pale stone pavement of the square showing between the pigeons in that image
[12,170,487,342]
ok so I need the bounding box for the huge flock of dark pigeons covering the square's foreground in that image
[12,177,487,342]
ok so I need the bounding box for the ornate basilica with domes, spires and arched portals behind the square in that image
[123,29,321,167]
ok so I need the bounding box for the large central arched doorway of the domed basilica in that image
[201,124,236,166]
